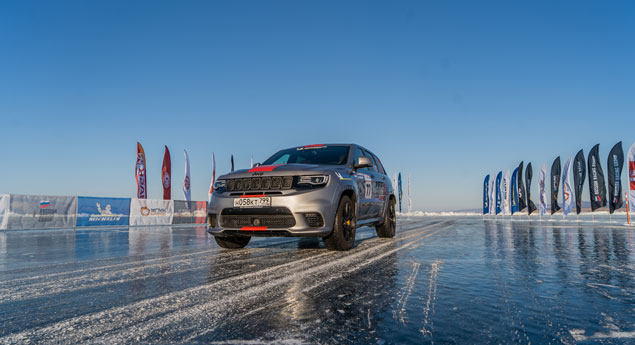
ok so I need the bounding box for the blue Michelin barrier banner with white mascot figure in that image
[76,196,130,226]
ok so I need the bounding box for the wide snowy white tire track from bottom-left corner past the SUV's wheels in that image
[0,219,444,343]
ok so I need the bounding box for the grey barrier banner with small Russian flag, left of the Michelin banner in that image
[5,194,77,230]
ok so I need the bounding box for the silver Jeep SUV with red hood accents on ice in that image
[207,144,396,250]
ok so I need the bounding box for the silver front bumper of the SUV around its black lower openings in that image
[207,182,341,237]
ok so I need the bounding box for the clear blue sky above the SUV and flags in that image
[0,1,635,211]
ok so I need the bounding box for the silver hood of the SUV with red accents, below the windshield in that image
[219,164,346,179]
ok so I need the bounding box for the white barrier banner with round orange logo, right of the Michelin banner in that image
[130,199,174,226]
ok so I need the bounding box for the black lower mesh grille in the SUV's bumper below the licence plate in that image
[220,207,295,229]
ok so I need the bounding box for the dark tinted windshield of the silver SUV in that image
[262,145,349,165]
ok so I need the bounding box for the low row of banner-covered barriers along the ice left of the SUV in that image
[0,194,207,230]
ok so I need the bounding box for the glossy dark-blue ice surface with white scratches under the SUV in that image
[0,216,635,344]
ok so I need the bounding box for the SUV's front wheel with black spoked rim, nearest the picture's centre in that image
[323,195,357,250]
